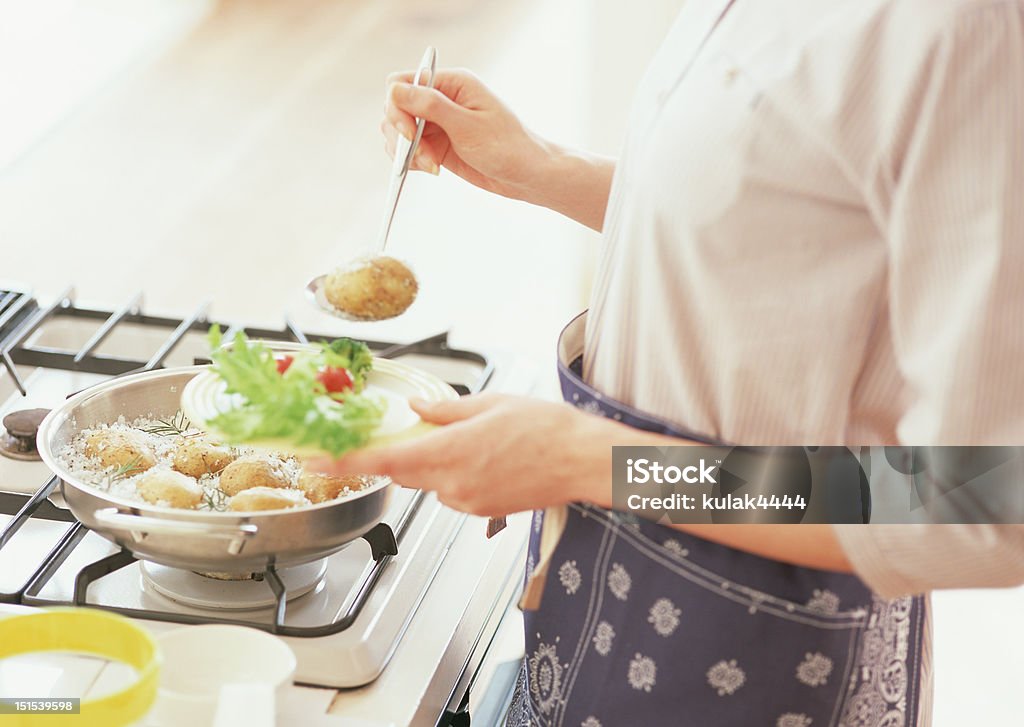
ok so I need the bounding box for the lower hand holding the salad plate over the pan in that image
[311,393,618,517]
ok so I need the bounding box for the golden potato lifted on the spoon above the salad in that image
[324,256,420,320]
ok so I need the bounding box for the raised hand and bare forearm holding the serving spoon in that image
[381,69,614,229]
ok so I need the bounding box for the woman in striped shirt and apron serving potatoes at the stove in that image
[325,0,1024,727]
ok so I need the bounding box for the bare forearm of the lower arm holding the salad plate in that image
[571,417,853,572]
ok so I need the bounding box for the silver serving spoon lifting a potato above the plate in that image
[306,47,437,320]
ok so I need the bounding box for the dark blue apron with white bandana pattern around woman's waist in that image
[507,316,926,727]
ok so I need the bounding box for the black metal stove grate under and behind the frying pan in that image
[0,288,494,637]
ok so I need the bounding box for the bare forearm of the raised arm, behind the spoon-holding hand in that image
[518,141,615,232]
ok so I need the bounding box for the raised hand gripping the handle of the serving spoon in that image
[381,70,550,201]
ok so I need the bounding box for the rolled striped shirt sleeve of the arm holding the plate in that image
[836,0,1024,597]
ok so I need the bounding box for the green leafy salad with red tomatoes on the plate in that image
[208,326,385,457]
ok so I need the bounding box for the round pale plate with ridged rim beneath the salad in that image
[181,341,459,458]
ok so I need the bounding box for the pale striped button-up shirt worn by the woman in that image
[584,0,1024,724]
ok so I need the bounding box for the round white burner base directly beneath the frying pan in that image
[141,558,327,611]
